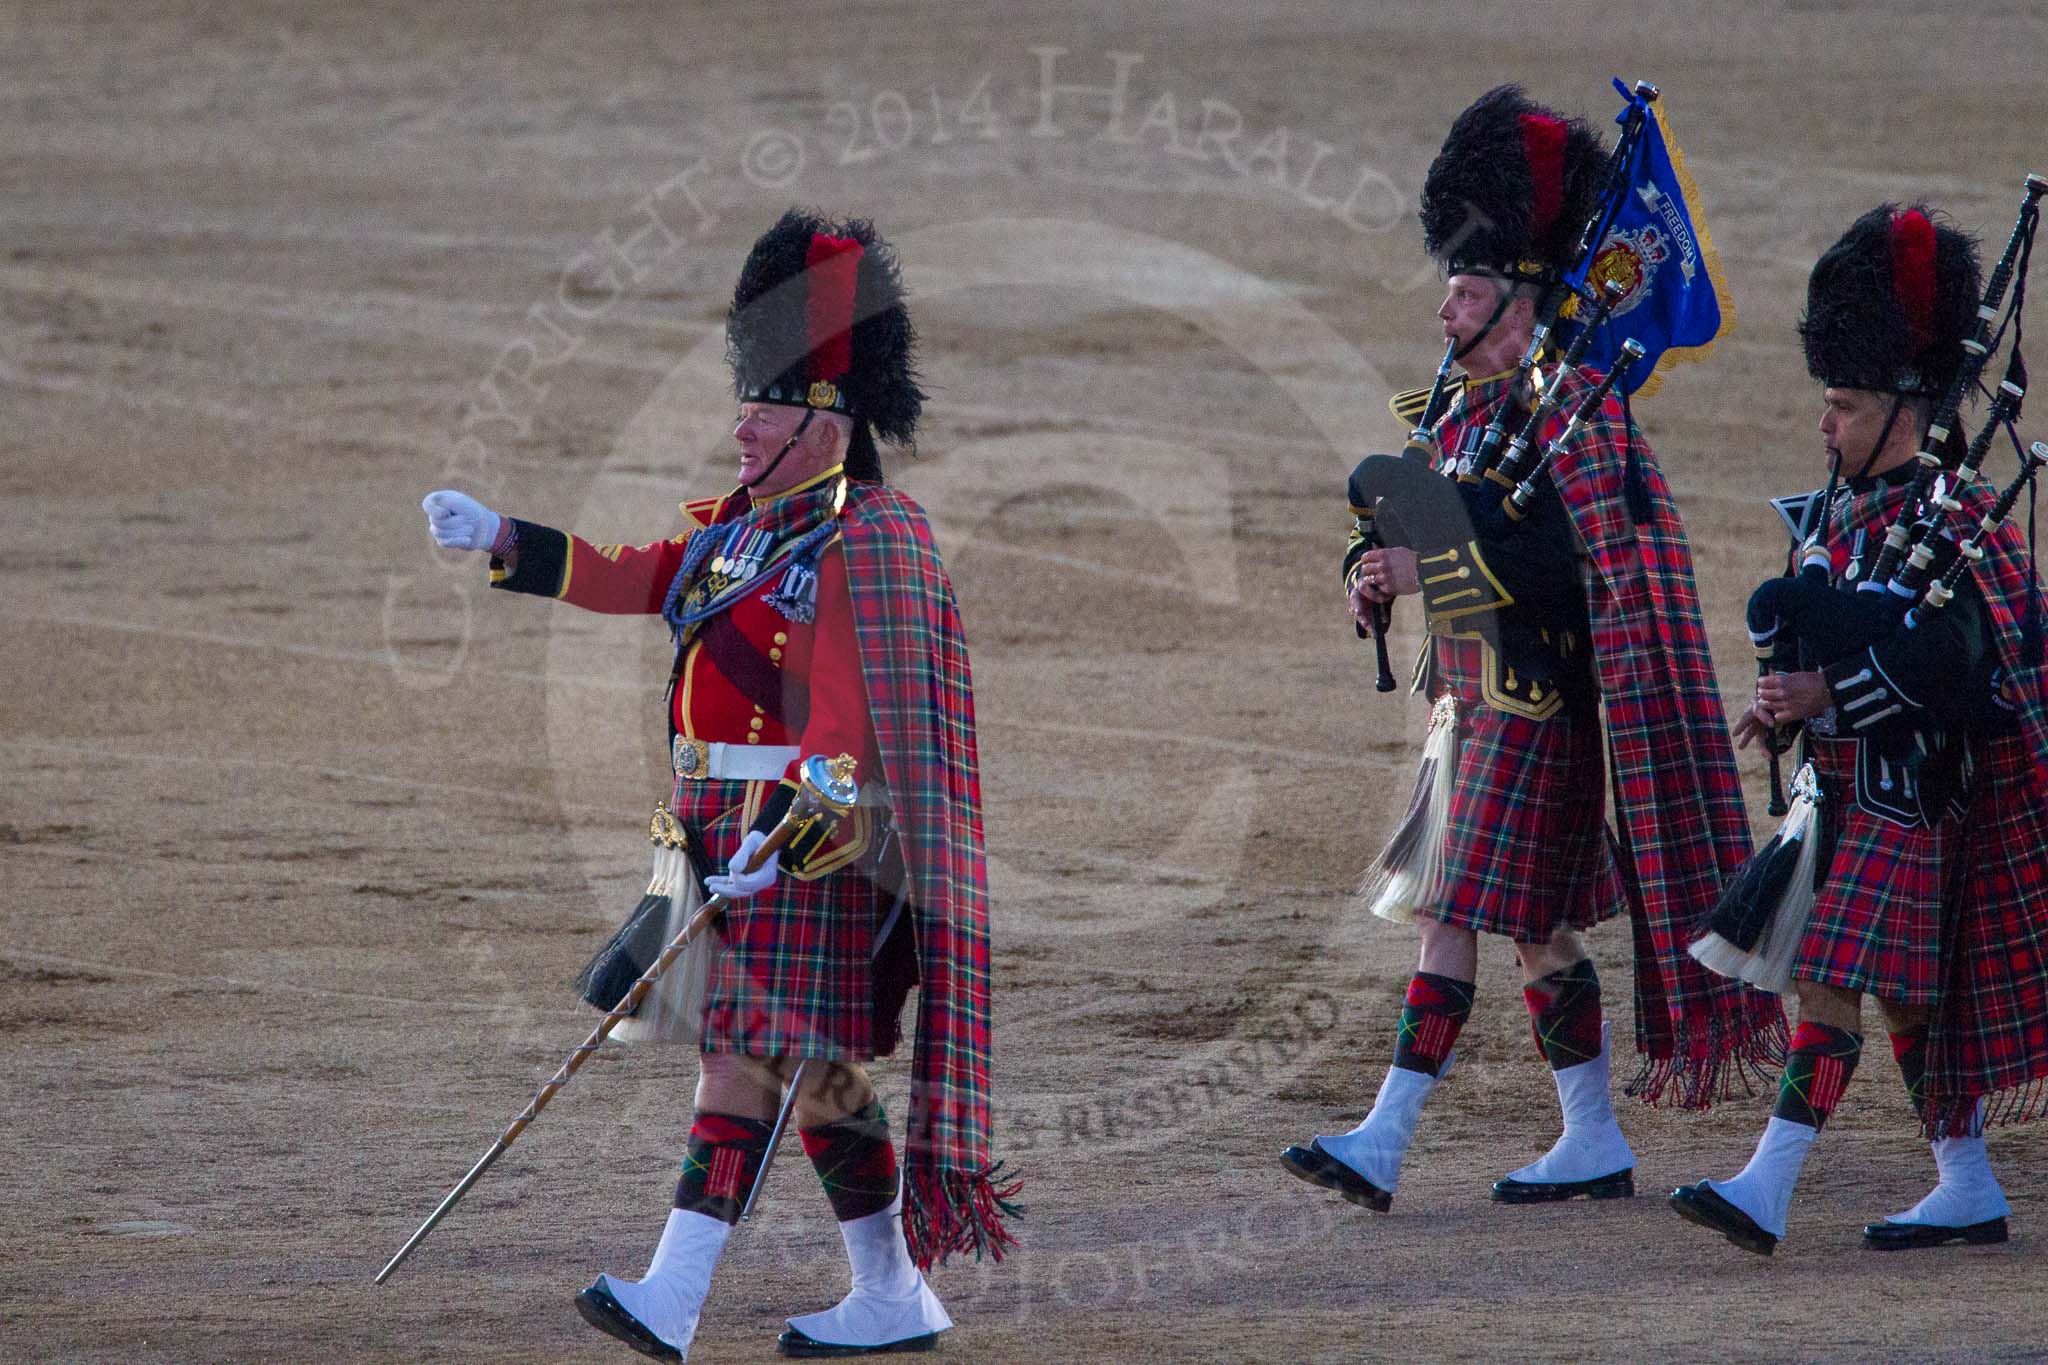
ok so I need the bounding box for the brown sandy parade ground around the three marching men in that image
[0,0,2048,1361]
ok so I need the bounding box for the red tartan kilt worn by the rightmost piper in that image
[1792,735,1958,1005]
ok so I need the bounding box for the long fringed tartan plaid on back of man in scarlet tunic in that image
[840,483,1016,1267]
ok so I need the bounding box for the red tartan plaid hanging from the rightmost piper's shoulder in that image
[1925,479,2048,1138]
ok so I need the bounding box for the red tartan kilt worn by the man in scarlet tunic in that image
[676,782,897,1062]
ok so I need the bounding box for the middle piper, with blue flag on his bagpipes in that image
[1280,86,1782,1212]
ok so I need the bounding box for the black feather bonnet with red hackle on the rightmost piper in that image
[1798,205,1982,397]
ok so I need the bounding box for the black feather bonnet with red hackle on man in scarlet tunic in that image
[725,209,924,483]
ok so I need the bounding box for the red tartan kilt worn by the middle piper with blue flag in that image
[1421,704,1626,943]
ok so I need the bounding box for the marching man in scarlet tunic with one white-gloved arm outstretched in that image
[426,211,1010,1359]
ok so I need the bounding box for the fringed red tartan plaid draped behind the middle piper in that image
[1546,370,1784,1109]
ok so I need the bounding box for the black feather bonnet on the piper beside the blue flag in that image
[1421,86,1608,282]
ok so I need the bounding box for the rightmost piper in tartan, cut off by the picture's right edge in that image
[1671,192,2048,1254]
